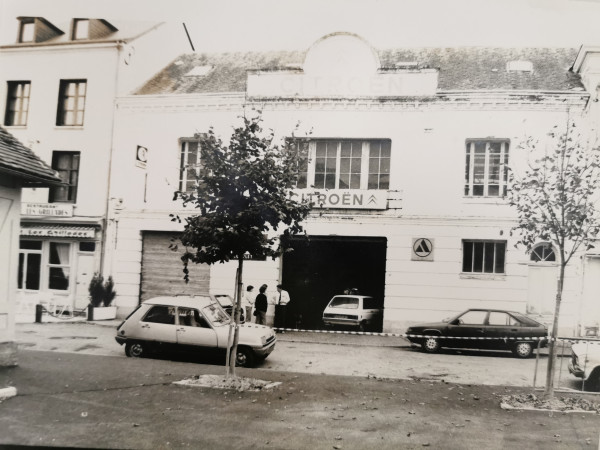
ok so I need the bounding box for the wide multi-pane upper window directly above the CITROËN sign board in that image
[297,139,391,189]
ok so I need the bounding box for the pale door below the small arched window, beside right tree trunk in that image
[527,265,557,315]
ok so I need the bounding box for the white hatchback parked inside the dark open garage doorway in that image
[323,295,383,331]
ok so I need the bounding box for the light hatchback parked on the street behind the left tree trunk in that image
[115,295,277,367]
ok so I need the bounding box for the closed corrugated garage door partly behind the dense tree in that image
[141,231,210,301]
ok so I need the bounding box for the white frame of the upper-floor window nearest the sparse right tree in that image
[464,138,510,198]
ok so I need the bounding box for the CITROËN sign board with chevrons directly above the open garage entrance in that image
[294,189,387,209]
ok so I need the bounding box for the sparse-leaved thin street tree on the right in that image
[508,122,600,398]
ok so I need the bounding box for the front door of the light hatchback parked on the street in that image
[176,307,218,354]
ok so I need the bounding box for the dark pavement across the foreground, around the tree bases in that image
[0,351,600,450]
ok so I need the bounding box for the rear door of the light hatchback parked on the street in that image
[137,305,177,350]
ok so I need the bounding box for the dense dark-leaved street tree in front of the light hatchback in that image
[171,111,310,376]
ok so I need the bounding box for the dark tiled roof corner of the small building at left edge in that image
[0,127,62,186]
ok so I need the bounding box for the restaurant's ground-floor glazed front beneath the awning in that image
[17,239,72,291]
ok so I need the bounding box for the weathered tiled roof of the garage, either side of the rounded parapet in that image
[135,47,583,95]
